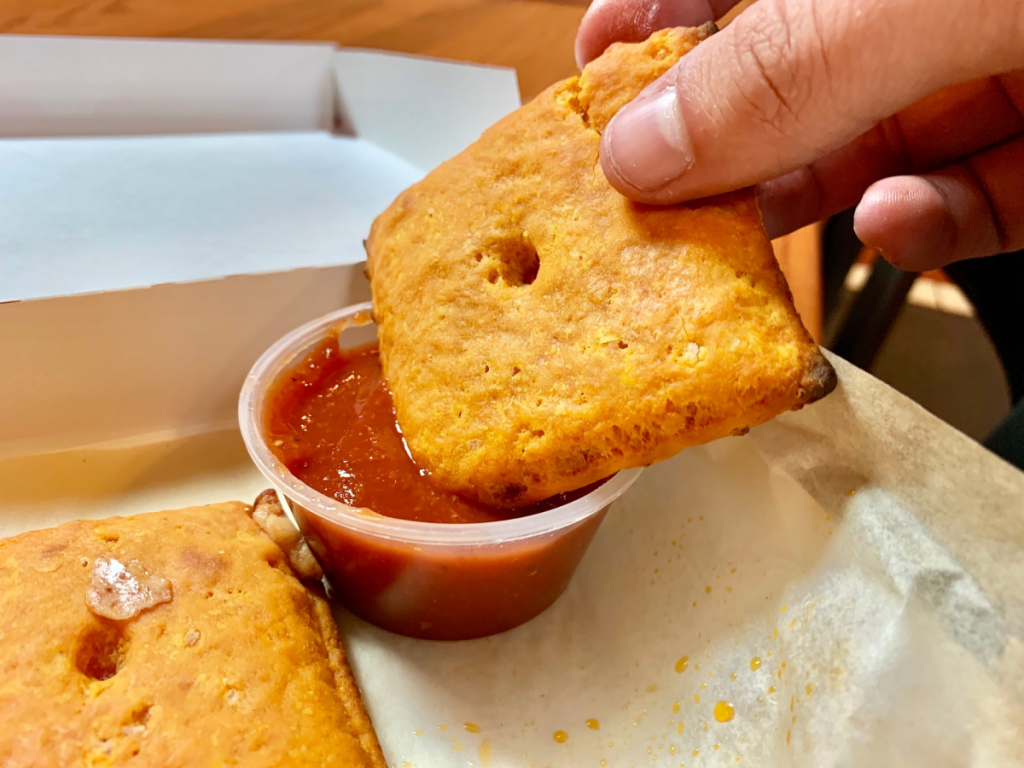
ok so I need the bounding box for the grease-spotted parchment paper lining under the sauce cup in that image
[0,361,1024,768]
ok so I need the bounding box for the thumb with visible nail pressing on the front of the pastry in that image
[601,0,1024,204]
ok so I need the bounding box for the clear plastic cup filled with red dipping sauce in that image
[240,313,639,640]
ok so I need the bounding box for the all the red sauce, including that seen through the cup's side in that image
[263,334,607,640]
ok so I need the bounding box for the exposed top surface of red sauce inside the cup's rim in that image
[266,337,600,523]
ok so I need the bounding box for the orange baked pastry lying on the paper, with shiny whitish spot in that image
[0,496,385,768]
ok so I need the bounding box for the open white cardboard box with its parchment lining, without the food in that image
[0,37,1024,768]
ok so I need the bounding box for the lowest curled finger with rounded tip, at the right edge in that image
[854,137,1024,271]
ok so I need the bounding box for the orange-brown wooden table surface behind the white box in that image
[0,0,821,337]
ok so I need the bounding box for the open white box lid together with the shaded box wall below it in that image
[0,36,519,454]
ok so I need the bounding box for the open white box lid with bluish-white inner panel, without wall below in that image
[0,37,519,301]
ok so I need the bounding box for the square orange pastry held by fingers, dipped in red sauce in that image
[367,25,836,506]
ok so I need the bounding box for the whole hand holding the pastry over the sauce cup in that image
[577,0,1024,270]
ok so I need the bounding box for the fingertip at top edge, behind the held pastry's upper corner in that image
[575,0,739,70]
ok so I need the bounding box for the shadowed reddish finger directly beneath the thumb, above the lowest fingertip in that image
[758,72,1024,238]
